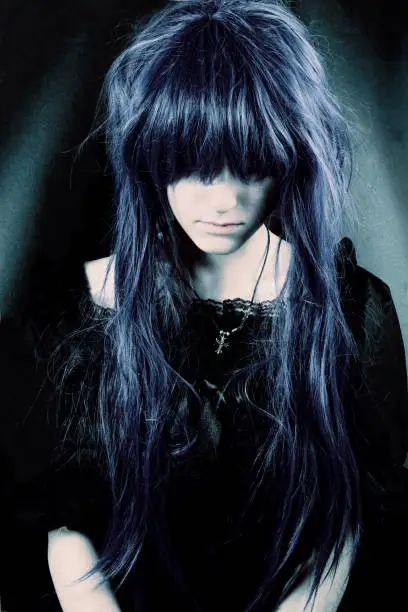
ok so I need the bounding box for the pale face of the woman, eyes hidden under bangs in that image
[167,168,276,255]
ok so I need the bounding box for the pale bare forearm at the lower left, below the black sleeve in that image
[48,527,120,612]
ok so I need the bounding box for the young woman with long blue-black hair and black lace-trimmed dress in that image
[27,0,408,612]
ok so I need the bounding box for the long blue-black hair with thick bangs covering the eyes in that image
[48,0,361,612]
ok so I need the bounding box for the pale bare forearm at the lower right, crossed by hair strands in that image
[276,535,352,612]
